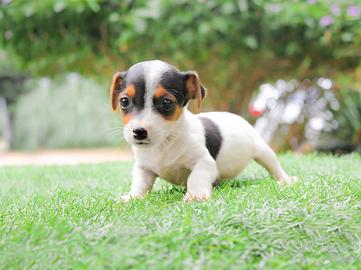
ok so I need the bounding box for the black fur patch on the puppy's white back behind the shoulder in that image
[199,117,223,160]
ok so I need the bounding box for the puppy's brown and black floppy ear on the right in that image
[185,71,207,109]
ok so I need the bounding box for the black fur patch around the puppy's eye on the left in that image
[124,64,145,111]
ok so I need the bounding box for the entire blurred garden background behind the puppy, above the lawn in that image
[0,0,361,162]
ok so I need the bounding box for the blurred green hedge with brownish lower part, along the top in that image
[0,0,361,112]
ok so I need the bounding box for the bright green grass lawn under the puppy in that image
[0,154,361,269]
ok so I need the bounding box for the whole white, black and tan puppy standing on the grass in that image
[110,60,296,202]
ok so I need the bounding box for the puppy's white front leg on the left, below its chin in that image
[121,163,156,202]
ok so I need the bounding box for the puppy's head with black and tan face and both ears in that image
[110,60,206,147]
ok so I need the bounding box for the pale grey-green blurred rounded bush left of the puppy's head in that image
[13,74,122,149]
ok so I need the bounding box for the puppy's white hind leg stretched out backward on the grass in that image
[254,138,297,184]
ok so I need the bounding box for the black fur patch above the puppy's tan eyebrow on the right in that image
[160,65,189,107]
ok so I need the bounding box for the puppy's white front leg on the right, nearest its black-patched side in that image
[183,157,218,202]
